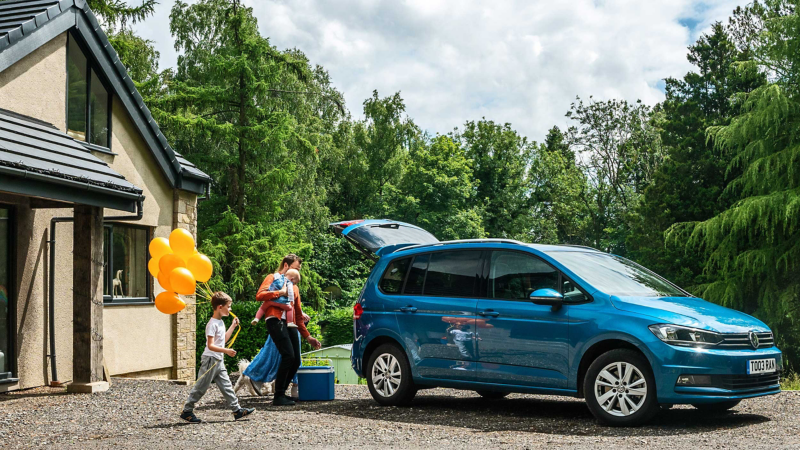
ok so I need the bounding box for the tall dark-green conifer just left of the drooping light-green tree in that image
[627,23,765,288]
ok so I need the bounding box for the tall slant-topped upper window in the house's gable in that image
[67,35,111,148]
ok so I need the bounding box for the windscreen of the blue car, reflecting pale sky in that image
[547,251,687,297]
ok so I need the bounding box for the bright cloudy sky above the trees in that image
[131,0,746,141]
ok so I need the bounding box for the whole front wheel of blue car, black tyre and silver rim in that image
[583,349,661,427]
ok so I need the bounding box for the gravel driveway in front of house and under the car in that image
[0,379,800,450]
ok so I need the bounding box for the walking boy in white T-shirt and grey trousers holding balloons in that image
[181,292,255,423]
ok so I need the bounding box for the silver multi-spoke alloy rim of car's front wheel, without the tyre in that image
[594,361,647,417]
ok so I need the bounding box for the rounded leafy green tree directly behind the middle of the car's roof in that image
[455,119,536,239]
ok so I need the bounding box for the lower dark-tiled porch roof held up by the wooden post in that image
[0,109,142,212]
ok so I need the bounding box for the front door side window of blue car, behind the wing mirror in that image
[489,252,560,300]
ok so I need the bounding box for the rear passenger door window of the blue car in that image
[424,251,481,297]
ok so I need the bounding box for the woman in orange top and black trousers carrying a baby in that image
[251,253,321,406]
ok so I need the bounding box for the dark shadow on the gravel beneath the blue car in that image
[276,395,769,436]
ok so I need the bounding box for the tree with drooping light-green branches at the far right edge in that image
[669,0,800,368]
